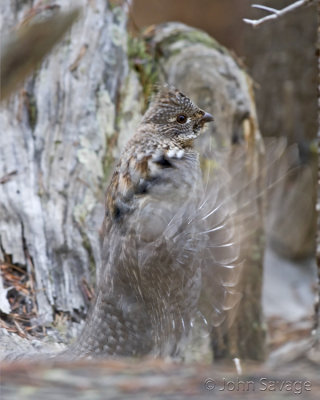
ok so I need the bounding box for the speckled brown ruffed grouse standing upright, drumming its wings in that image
[68,87,238,357]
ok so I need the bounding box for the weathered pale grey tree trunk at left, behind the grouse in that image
[0,0,132,323]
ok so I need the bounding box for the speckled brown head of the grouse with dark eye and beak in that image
[142,85,213,142]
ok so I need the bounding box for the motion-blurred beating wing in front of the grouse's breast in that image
[191,139,308,338]
